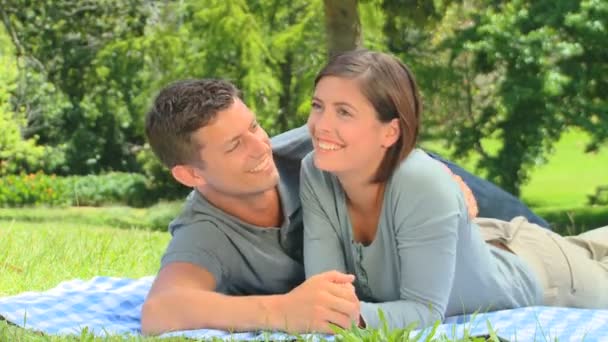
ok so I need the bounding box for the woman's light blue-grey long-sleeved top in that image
[300,149,543,328]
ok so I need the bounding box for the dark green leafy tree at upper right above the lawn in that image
[447,0,608,195]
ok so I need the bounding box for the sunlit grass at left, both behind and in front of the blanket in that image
[0,214,169,341]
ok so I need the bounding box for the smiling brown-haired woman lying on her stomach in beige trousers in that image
[300,50,608,328]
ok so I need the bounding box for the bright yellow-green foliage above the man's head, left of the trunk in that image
[142,0,325,134]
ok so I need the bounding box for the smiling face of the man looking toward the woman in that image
[192,98,279,196]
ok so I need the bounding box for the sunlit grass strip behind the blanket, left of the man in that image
[0,221,169,296]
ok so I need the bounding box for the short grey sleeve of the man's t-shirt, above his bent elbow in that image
[161,221,232,288]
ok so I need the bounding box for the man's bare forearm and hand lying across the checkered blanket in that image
[141,262,359,335]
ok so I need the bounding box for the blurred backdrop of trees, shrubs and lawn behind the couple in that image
[0,0,608,231]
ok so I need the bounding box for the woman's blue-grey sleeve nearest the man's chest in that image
[300,154,346,279]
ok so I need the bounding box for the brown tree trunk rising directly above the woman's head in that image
[323,0,362,56]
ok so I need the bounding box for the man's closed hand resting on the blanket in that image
[277,271,360,333]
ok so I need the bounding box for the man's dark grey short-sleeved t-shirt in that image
[161,130,311,295]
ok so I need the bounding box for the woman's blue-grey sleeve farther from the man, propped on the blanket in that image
[361,154,463,328]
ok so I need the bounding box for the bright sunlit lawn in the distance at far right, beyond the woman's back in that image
[423,130,608,234]
